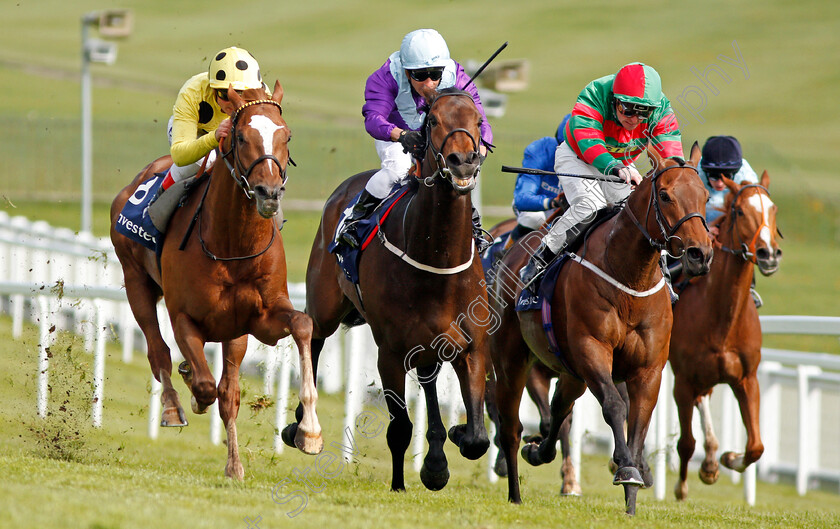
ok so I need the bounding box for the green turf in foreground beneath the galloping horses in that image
[0,317,840,529]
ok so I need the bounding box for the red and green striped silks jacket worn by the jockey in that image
[566,75,683,174]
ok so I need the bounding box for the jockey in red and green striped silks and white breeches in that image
[521,63,683,283]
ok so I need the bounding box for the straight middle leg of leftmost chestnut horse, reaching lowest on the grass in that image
[218,336,248,481]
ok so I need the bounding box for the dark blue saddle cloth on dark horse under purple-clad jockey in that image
[327,184,416,284]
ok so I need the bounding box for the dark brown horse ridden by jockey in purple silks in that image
[283,88,493,491]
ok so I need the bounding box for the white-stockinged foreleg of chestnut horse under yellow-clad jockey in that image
[285,311,324,454]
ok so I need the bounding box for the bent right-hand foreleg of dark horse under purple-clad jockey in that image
[449,340,490,460]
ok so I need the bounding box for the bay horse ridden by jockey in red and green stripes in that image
[490,143,712,514]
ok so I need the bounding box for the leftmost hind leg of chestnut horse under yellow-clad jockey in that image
[123,267,187,426]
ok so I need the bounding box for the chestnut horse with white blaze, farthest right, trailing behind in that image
[670,171,782,500]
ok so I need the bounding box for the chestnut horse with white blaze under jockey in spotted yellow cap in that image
[111,81,323,480]
